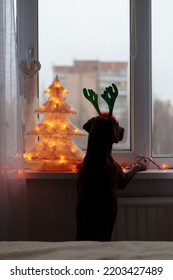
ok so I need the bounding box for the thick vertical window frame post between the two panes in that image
[130,0,152,162]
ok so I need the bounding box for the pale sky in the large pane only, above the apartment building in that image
[39,0,129,89]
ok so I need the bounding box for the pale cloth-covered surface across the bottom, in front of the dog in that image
[0,241,173,260]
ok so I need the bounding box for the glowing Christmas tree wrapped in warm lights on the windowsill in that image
[24,77,85,172]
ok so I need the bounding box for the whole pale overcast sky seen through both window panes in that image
[39,0,173,103]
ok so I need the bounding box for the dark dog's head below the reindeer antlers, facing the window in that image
[83,116,124,144]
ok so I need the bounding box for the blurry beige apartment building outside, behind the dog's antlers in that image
[53,60,130,148]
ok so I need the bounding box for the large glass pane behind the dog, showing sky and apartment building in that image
[39,0,130,150]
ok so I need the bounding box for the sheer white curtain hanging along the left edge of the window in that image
[0,0,28,241]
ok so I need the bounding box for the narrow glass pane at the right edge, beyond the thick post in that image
[152,0,173,156]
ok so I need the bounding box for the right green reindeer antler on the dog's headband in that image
[101,84,118,115]
